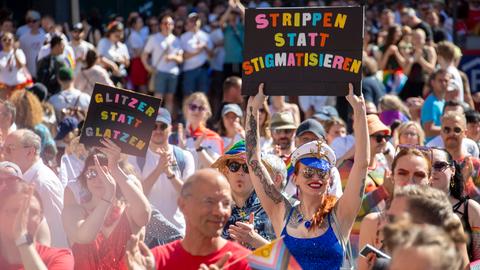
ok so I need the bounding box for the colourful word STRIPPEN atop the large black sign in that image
[255,12,347,29]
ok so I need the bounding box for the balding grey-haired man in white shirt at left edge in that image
[3,129,68,247]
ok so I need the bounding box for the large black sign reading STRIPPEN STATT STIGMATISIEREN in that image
[242,7,363,96]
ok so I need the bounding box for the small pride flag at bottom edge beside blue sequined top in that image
[247,237,302,270]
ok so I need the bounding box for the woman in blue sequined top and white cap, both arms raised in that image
[246,84,370,269]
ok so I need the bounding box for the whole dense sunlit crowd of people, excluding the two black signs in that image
[0,0,480,270]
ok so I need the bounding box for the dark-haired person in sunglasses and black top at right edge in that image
[432,148,480,262]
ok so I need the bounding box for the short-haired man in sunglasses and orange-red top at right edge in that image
[441,112,480,202]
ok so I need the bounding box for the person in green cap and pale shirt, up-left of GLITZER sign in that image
[48,67,90,120]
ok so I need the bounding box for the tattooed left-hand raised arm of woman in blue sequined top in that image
[245,84,290,236]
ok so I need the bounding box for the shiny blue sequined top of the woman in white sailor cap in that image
[282,207,344,270]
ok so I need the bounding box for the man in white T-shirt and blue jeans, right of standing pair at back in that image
[180,12,213,96]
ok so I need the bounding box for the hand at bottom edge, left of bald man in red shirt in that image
[126,235,155,270]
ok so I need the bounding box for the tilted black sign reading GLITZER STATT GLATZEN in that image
[80,83,161,157]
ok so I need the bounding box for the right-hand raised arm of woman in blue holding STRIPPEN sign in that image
[336,84,370,237]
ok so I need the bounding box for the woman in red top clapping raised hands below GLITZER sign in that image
[62,139,150,269]
